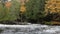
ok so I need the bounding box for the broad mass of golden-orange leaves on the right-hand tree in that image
[45,0,60,13]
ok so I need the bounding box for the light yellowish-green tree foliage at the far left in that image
[0,0,20,21]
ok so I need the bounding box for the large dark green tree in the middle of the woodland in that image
[24,0,45,20]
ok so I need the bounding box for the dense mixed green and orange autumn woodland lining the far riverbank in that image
[0,0,60,25]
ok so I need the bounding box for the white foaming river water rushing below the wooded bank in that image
[0,24,60,34]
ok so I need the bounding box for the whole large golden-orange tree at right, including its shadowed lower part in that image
[45,0,60,20]
